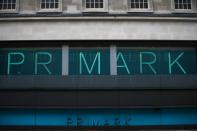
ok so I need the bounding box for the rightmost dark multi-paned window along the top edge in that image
[174,0,192,10]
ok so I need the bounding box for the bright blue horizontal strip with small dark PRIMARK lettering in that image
[0,108,197,127]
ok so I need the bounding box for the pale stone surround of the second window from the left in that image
[37,0,62,12]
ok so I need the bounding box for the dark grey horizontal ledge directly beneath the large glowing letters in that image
[0,75,197,90]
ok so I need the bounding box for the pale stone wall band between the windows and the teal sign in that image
[0,17,197,41]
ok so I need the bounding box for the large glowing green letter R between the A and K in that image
[140,52,157,74]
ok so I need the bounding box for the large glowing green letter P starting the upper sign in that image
[7,52,25,75]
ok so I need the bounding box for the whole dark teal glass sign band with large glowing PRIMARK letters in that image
[0,47,197,75]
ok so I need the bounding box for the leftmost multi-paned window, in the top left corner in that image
[0,0,16,10]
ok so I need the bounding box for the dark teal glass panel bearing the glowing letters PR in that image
[0,48,62,75]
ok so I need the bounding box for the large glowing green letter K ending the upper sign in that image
[168,52,187,74]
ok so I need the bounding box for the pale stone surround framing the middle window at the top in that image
[82,0,109,12]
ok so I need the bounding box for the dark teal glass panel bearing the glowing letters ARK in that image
[117,48,197,75]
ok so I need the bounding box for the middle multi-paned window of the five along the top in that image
[85,0,104,8]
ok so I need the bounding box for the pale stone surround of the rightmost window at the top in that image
[171,0,196,13]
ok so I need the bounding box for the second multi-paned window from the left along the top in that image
[40,0,60,9]
